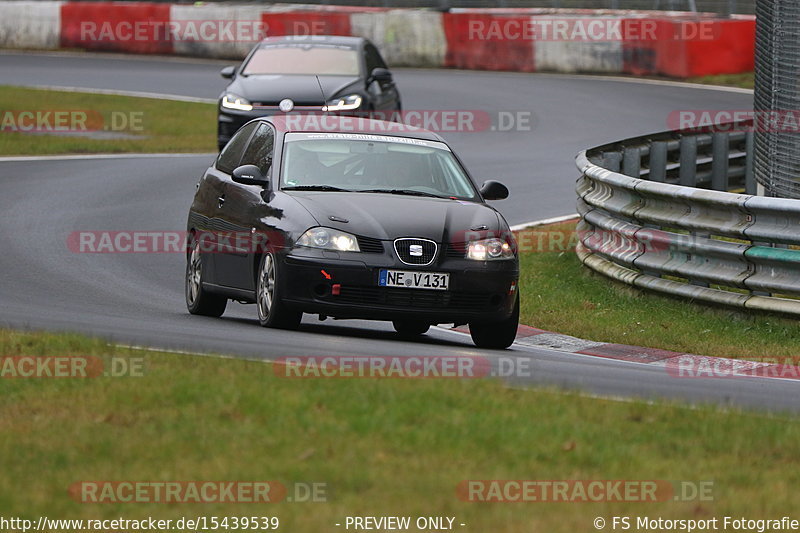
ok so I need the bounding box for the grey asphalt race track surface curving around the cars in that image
[0,54,800,411]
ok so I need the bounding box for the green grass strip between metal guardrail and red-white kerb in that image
[520,223,800,358]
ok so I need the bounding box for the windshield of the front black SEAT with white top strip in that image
[281,133,478,200]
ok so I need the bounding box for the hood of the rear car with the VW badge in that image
[225,74,359,105]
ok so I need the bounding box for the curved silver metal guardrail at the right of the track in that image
[576,123,800,315]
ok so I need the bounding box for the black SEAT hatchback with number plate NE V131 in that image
[191,116,519,348]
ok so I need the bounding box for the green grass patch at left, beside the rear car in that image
[0,86,216,155]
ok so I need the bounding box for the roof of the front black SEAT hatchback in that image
[259,115,445,142]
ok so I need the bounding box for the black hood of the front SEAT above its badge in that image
[286,191,505,242]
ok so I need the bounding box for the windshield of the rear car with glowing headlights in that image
[242,44,359,76]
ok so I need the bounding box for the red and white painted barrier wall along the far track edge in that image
[0,0,755,77]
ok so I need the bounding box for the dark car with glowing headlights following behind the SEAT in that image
[217,36,401,150]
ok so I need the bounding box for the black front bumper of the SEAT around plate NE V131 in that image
[282,249,519,324]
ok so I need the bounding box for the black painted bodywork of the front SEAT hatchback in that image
[187,117,519,324]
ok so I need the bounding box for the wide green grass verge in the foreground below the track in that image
[0,330,800,533]
